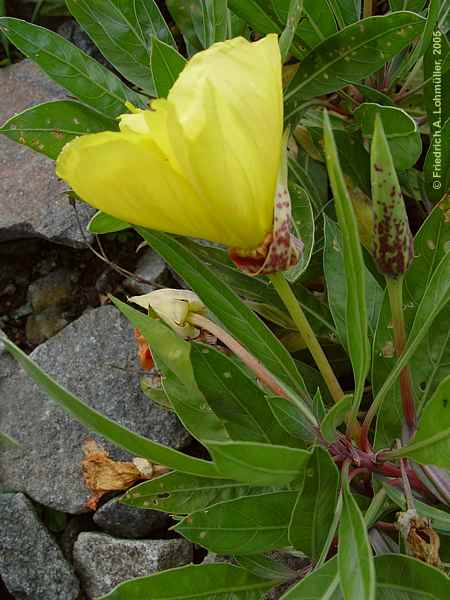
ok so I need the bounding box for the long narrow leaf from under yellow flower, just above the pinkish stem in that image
[138,228,316,414]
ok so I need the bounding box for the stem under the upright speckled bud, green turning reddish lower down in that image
[386,277,416,439]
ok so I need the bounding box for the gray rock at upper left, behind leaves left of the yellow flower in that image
[0,60,95,246]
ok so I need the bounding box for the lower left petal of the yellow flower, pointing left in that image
[56,130,230,243]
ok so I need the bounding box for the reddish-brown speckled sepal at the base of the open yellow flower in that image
[229,182,303,276]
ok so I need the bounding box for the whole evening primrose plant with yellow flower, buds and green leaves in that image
[0,0,450,600]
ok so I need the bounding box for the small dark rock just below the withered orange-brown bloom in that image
[94,498,169,539]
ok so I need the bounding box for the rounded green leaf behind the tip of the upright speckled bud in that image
[353,102,422,171]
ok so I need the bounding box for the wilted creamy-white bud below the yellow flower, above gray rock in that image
[128,288,206,338]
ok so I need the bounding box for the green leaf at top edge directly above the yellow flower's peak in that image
[166,0,228,50]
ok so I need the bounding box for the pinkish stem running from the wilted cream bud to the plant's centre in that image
[187,313,319,433]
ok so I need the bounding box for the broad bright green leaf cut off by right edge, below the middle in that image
[393,375,450,469]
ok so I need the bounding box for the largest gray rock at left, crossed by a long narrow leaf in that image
[0,306,190,514]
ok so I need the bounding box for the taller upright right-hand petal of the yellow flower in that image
[168,35,283,248]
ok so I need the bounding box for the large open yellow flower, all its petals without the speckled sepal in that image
[56,34,283,249]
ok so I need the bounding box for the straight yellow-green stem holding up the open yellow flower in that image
[269,273,344,402]
